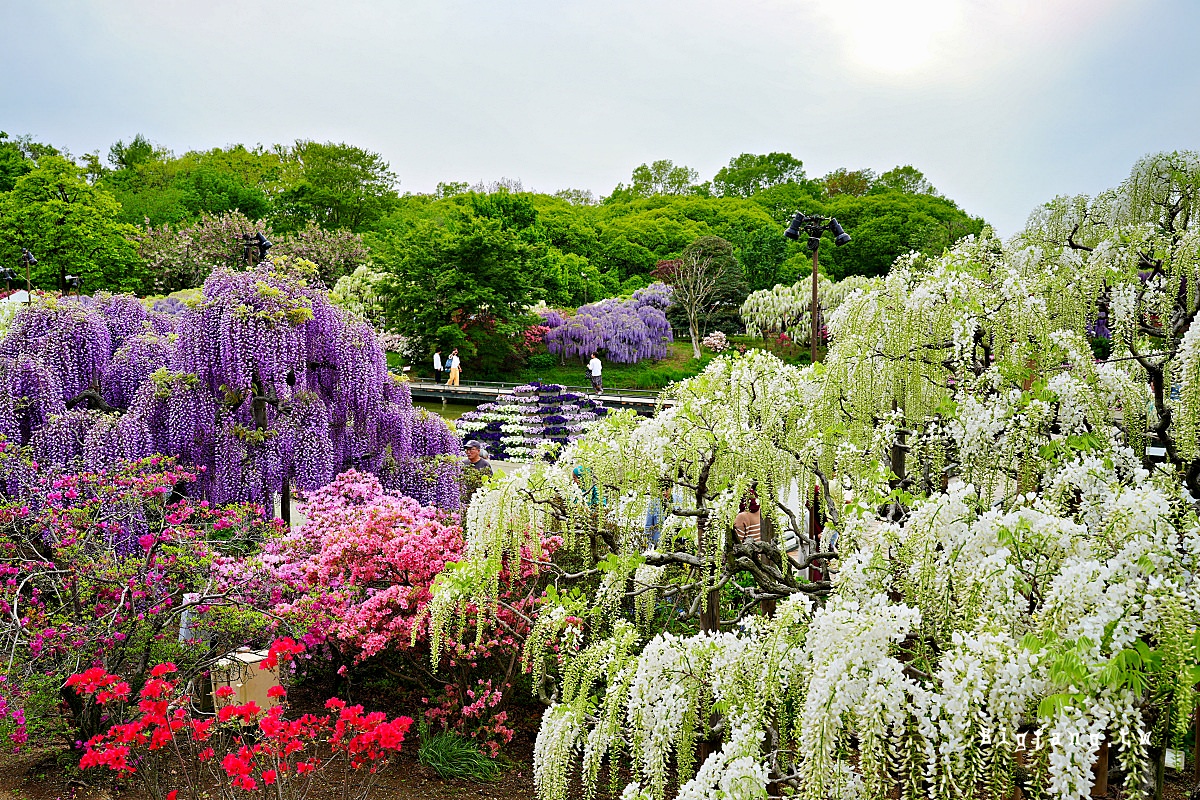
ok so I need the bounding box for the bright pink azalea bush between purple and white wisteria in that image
[237,470,553,754]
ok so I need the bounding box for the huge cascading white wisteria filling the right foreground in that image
[431,154,1200,800]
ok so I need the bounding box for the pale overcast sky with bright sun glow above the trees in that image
[0,0,1200,235]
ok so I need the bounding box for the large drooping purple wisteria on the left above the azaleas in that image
[0,263,462,509]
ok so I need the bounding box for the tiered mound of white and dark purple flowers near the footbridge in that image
[455,383,608,461]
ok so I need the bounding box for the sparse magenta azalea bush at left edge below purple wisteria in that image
[0,456,278,739]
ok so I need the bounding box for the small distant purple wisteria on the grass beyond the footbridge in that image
[542,283,674,363]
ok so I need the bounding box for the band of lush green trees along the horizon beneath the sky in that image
[0,133,984,374]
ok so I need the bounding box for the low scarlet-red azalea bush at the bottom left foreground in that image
[75,639,413,800]
